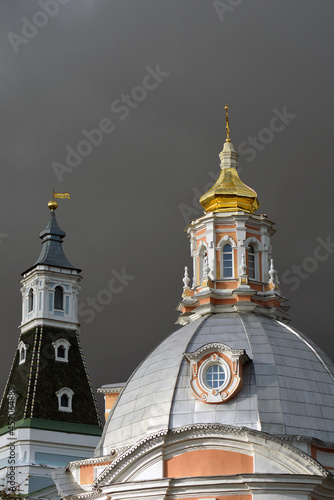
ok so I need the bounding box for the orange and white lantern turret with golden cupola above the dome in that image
[178,106,287,325]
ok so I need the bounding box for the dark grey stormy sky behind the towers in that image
[0,0,334,410]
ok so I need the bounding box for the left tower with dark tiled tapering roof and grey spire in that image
[0,200,101,498]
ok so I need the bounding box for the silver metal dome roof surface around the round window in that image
[96,313,334,455]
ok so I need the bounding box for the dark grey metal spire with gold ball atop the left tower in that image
[23,200,81,274]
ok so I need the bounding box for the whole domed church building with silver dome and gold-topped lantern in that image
[51,110,334,500]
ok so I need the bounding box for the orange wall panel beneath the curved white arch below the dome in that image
[164,450,253,477]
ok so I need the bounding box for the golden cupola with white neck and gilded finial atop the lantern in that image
[199,105,260,213]
